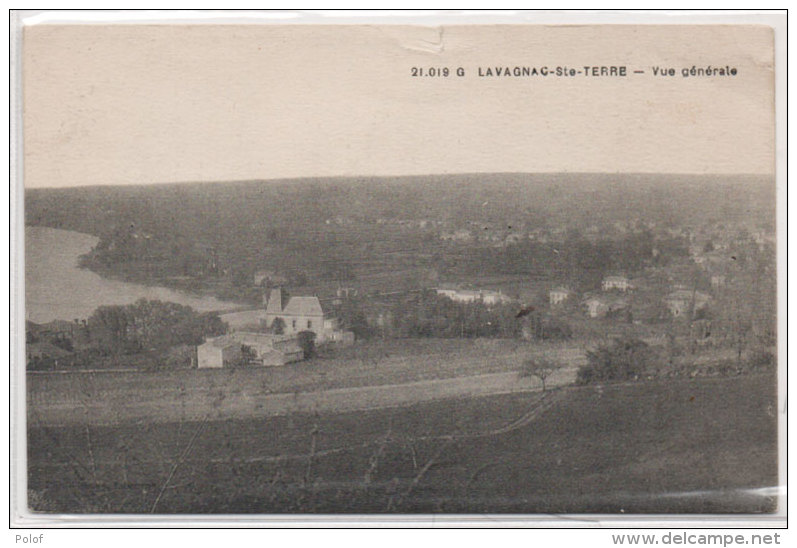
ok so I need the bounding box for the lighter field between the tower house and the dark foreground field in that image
[27,339,584,425]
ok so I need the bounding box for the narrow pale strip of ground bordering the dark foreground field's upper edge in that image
[28,368,576,425]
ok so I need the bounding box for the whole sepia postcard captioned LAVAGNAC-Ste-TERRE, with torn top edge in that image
[12,13,785,519]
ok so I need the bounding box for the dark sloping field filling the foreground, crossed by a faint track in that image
[28,375,777,513]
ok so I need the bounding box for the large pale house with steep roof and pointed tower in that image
[265,288,353,342]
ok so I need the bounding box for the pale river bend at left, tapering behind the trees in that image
[25,226,241,323]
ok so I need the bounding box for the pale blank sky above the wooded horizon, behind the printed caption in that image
[23,25,775,188]
